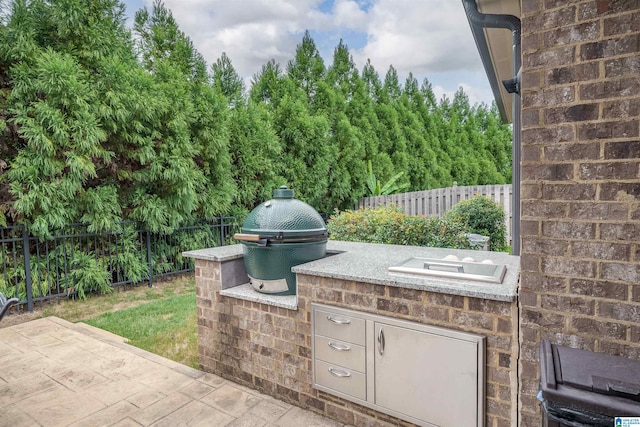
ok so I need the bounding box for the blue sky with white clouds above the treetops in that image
[122,0,493,105]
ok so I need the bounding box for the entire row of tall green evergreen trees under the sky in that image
[0,0,511,237]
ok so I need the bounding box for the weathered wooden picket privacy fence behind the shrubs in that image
[357,184,513,244]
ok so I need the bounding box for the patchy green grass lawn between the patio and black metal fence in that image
[0,277,199,369]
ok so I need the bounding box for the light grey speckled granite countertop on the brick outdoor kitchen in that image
[183,240,520,302]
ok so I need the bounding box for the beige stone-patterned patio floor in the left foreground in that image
[0,317,342,427]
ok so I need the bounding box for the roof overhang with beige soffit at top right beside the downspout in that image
[467,0,521,122]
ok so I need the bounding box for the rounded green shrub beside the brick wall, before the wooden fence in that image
[445,195,507,251]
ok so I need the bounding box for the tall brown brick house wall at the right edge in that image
[520,0,640,426]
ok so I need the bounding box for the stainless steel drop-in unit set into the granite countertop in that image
[389,257,507,283]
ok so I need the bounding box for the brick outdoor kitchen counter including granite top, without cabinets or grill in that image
[185,241,519,427]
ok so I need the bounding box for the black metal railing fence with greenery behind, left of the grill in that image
[0,217,242,311]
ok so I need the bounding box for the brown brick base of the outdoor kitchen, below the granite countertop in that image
[186,244,518,427]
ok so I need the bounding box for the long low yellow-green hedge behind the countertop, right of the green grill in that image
[327,207,469,249]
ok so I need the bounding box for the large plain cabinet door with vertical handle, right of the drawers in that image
[374,322,482,427]
